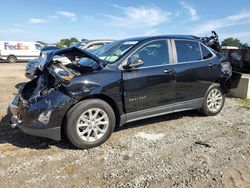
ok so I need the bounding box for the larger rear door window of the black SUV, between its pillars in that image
[175,40,202,63]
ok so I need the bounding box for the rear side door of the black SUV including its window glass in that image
[172,39,220,105]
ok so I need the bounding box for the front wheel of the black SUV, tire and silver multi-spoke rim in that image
[65,99,116,149]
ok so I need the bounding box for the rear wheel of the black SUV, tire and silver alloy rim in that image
[200,84,225,116]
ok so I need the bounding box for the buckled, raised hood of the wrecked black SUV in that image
[38,46,106,71]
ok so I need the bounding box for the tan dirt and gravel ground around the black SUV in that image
[0,63,250,188]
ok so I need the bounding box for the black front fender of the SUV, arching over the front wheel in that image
[65,69,124,114]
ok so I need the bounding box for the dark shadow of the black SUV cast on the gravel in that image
[0,109,202,150]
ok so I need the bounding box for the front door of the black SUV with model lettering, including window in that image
[123,40,175,116]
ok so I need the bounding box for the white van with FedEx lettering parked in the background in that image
[0,41,43,63]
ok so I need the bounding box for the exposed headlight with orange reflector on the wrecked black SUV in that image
[50,65,74,82]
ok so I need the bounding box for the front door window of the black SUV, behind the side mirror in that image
[130,40,169,67]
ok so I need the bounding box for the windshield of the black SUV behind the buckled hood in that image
[79,41,139,64]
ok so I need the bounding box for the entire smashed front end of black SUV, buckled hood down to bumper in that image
[10,47,103,140]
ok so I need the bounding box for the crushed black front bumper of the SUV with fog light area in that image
[9,91,75,140]
